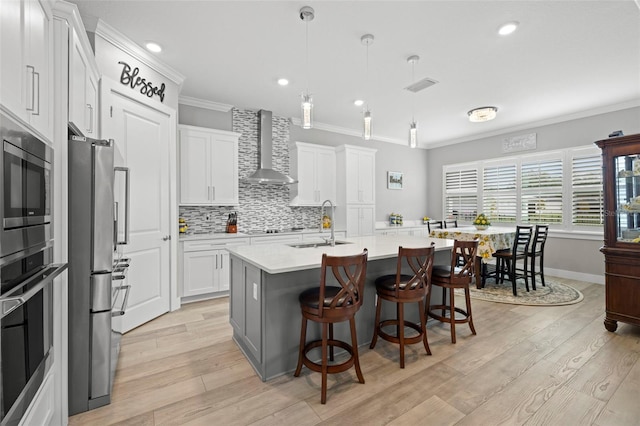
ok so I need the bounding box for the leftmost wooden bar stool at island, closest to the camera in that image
[293,249,368,404]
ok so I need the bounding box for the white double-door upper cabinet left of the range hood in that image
[179,125,240,206]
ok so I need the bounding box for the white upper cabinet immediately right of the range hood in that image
[289,142,336,206]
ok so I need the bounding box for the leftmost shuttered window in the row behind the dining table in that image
[444,167,478,221]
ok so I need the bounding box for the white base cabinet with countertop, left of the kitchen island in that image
[182,238,249,297]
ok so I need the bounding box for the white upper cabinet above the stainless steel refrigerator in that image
[69,27,100,138]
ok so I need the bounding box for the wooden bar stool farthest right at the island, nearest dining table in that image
[427,240,478,343]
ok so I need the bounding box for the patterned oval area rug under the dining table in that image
[456,279,584,306]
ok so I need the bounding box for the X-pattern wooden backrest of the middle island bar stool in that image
[395,243,436,298]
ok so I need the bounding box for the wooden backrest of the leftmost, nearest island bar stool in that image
[318,249,369,317]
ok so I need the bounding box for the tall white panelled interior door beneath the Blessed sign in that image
[102,81,172,332]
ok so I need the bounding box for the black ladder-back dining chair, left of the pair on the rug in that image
[493,225,535,296]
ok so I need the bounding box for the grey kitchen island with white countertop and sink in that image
[228,235,453,381]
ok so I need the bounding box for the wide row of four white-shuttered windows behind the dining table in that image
[443,146,604,231]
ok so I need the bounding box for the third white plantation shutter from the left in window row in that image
[520,158,562,223]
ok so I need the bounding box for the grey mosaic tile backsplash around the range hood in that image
[176,108,320,233]
